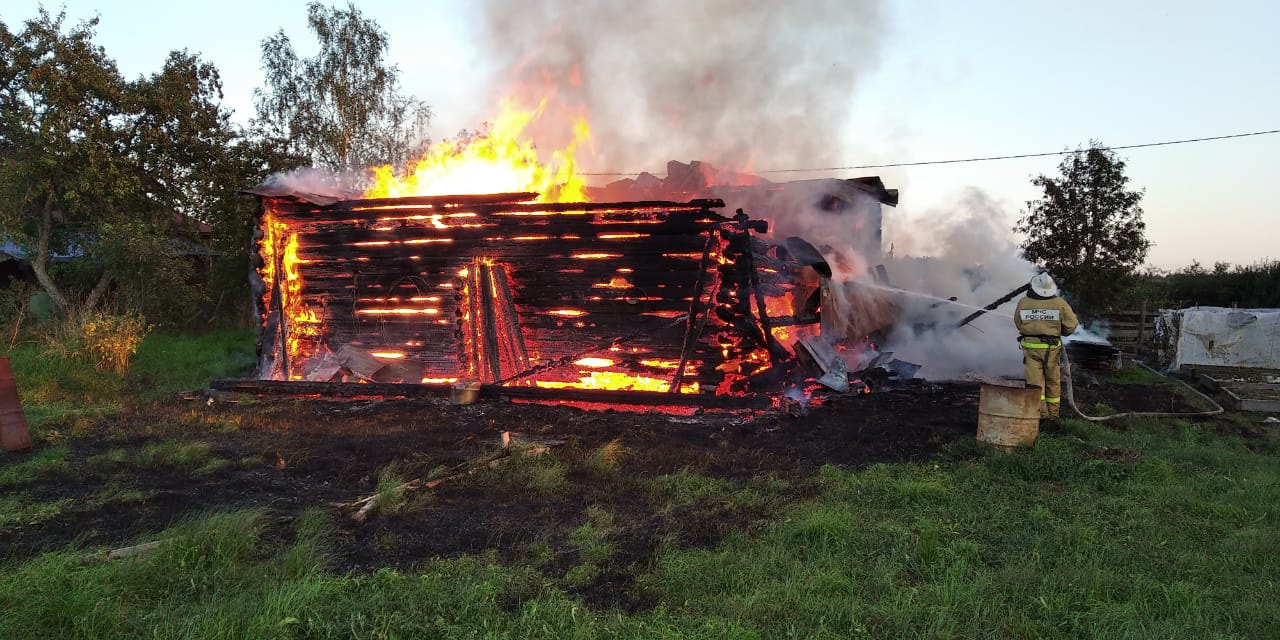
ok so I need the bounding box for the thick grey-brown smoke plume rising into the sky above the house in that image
[479,0,884,170]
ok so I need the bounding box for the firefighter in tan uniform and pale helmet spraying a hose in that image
[1014,274,1079,420]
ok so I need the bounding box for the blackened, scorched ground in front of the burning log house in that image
[0,373,1239,608]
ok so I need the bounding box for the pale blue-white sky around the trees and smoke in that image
[0,0,1280,269]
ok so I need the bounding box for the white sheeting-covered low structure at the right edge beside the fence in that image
[1156,307,1280,369]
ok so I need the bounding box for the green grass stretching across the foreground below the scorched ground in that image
[0,420,1280,639]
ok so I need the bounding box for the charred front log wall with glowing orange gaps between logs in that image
[253,196,757,393]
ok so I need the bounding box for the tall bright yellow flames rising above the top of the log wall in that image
[365,100,591,202]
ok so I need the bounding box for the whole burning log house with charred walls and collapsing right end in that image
[241,165,896,404]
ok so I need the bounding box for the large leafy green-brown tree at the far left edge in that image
[0,9,244,316]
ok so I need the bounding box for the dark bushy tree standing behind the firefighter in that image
[1014,141,1151,310]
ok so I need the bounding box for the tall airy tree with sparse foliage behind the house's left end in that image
[253,3,431,170]
